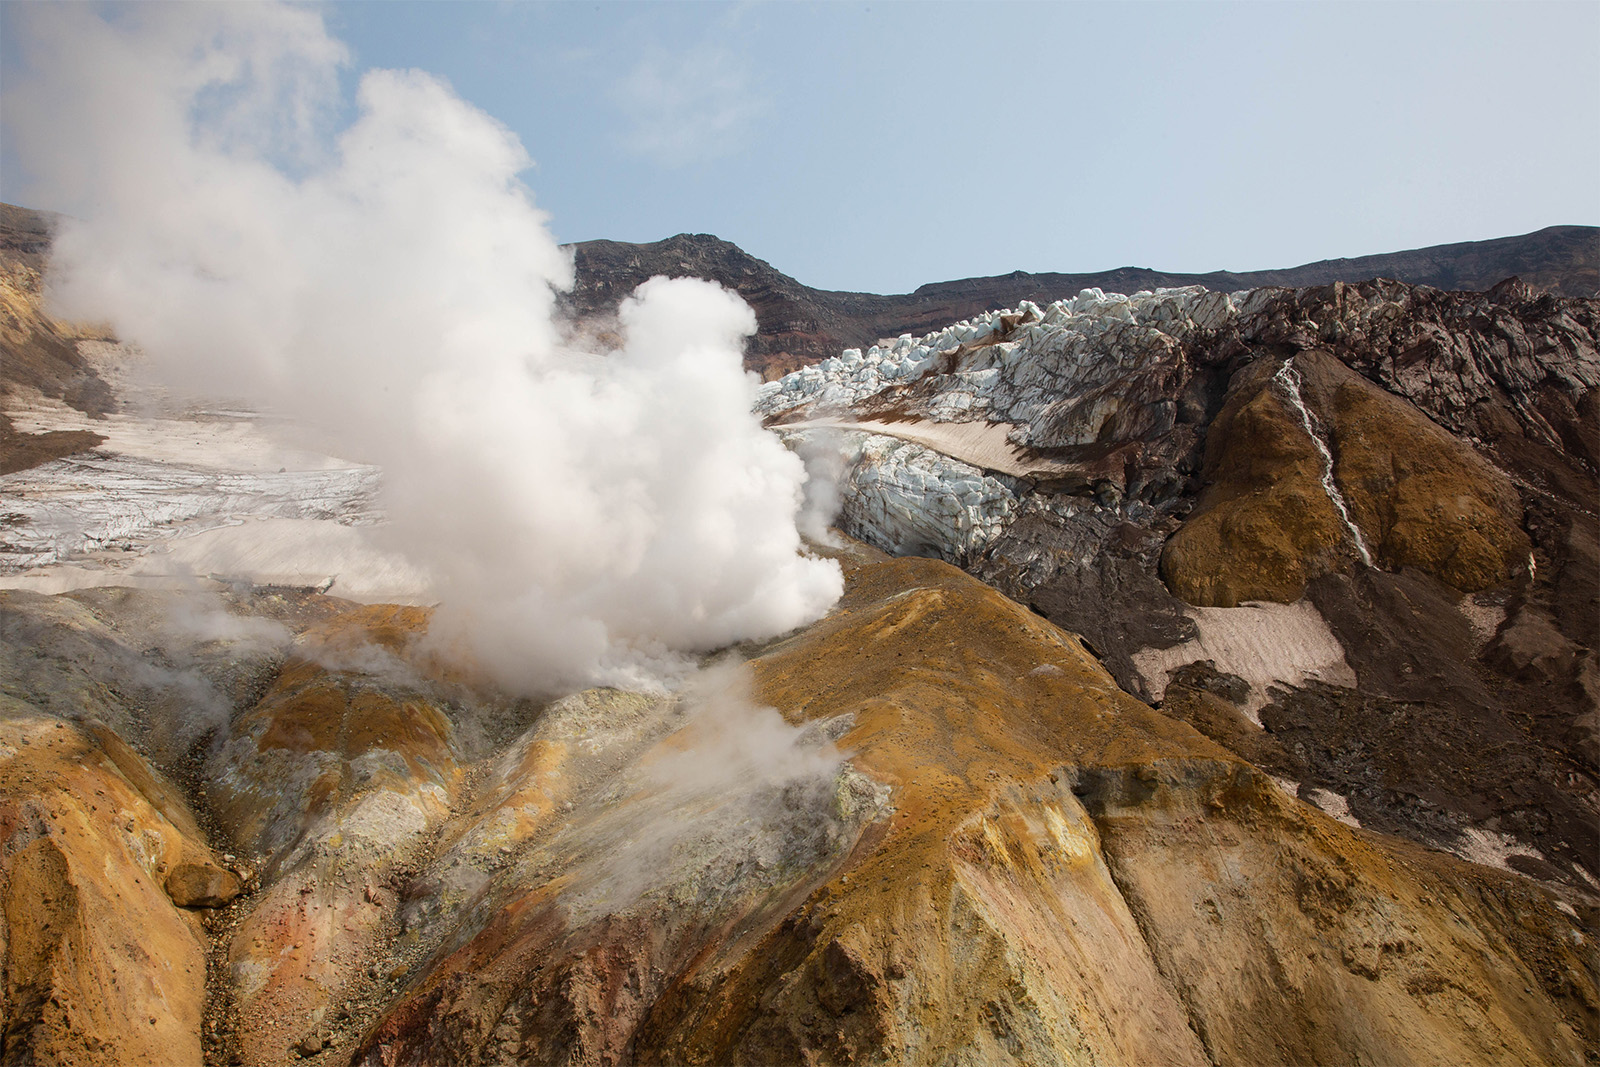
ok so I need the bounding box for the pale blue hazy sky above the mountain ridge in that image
[0,0,1600,293]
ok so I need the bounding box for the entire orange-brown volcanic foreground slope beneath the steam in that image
[0,544,1600,1065]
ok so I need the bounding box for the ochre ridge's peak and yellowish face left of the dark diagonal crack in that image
[627,558,1232,1064]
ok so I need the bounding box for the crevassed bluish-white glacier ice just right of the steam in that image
[755,286,1237,563]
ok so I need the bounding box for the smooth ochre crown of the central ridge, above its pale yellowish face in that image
[752,558,1235,835]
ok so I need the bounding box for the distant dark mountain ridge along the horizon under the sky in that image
[563,226,1600,379]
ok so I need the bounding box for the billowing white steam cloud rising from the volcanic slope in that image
[6,5,842,691]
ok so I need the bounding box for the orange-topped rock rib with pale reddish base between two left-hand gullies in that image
[211,605,462,1065]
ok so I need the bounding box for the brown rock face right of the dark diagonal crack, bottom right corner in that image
[1085,765,1600,1064]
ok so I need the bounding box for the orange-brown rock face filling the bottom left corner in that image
[0,710,237,1067]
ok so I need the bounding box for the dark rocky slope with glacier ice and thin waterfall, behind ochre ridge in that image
[760,273,1600,888]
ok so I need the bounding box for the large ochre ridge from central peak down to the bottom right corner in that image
[661,561,1594,1064]
